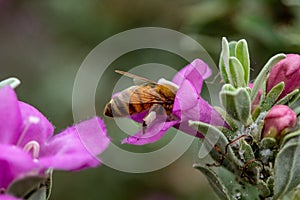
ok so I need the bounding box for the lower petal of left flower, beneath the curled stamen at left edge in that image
[0,145,37,189]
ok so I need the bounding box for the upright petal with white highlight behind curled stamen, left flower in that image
[18,101,54,147]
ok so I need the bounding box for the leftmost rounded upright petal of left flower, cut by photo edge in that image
[0,86,22,144]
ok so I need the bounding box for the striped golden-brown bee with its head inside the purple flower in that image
[104,70,178,133]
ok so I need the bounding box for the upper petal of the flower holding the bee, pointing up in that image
[172,58,212,94]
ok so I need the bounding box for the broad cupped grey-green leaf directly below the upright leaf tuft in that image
[220,88,252,125]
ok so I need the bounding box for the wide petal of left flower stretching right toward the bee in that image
[39,117,109,170]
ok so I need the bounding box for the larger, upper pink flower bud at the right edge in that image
[267,54,300,99]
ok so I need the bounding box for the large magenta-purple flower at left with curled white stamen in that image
[0,86,109,190]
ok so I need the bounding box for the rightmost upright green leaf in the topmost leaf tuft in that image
[235,39,250,85]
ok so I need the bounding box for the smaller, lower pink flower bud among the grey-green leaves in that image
[262,105,297,138]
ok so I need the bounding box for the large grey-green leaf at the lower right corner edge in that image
[274,130,300,199]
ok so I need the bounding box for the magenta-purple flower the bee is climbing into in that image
[122,59,226,145]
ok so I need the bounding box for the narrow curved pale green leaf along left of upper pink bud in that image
[251,53,286,102]
